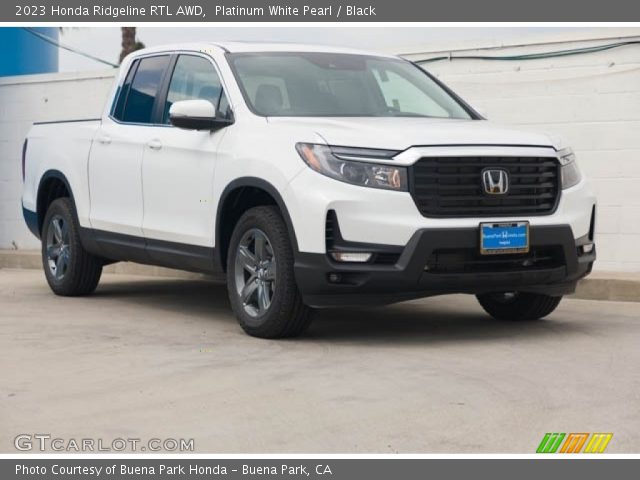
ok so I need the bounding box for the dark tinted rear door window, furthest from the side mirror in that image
[114,55,169,123]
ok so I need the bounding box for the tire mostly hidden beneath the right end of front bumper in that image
[476,292,562,321]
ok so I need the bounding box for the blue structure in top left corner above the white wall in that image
[0,27,59,77]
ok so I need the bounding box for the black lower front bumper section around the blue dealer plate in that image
[295,225,596,307]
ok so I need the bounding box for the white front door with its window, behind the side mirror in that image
[142,53,233,247]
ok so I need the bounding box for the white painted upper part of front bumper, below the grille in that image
[283,168,596,253]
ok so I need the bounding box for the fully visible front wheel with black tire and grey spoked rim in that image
[227,206,312,338]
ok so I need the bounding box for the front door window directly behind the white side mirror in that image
[163,55,228,124]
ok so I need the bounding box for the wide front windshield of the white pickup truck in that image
[228,52,472,119]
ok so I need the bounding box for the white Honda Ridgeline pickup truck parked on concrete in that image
[22,43,595,338]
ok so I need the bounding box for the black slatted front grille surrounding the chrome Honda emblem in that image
[410,157,560,217]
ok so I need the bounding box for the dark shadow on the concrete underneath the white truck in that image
[94,278,587,345]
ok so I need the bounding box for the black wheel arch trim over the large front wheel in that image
[215,177,298,271]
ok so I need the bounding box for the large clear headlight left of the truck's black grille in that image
[296,143,409,192]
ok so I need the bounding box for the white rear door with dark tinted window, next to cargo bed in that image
[89,55,170,238]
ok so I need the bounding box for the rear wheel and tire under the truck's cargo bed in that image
[42,198,102,296]
